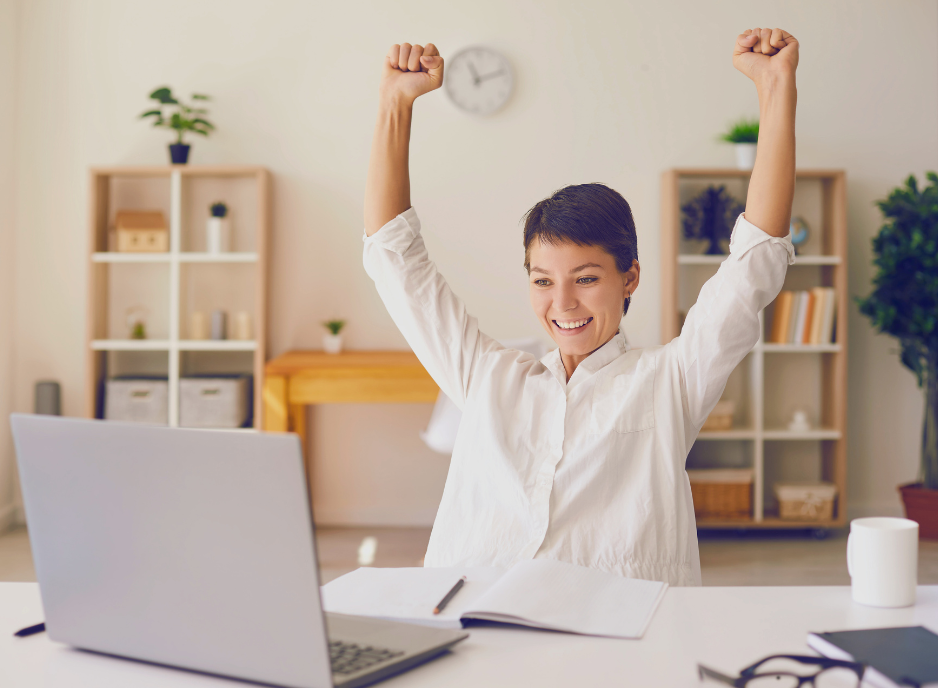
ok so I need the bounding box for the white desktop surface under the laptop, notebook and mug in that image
[0,583,938,688]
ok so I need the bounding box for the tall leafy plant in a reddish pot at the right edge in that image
[857,172,938,539]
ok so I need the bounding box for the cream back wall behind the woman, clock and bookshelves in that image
[7,0,938,523]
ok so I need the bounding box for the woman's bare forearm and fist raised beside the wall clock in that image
[365,43,443,236]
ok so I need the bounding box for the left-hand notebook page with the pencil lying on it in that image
[322,567,504,628]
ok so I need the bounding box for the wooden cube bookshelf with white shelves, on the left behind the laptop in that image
[85,165,271,429]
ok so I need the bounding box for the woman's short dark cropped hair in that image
[524,184,638,314]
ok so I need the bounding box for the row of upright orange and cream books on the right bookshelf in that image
[769,287,837,344]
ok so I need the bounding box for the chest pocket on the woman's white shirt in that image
[590,356,655,434]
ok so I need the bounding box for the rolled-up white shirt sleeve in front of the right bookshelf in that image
[669,214,795,431]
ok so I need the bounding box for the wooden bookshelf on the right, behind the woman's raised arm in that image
[661,168,848,531]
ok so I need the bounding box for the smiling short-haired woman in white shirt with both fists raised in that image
[364,28,798,585]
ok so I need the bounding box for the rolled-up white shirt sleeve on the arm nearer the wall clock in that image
[364,208,503,409]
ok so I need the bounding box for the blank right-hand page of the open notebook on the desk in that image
[463,559,668,638]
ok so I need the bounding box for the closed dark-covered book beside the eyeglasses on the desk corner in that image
[808,626,938,688]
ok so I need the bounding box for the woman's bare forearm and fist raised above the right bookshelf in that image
[733,29,798,237]
